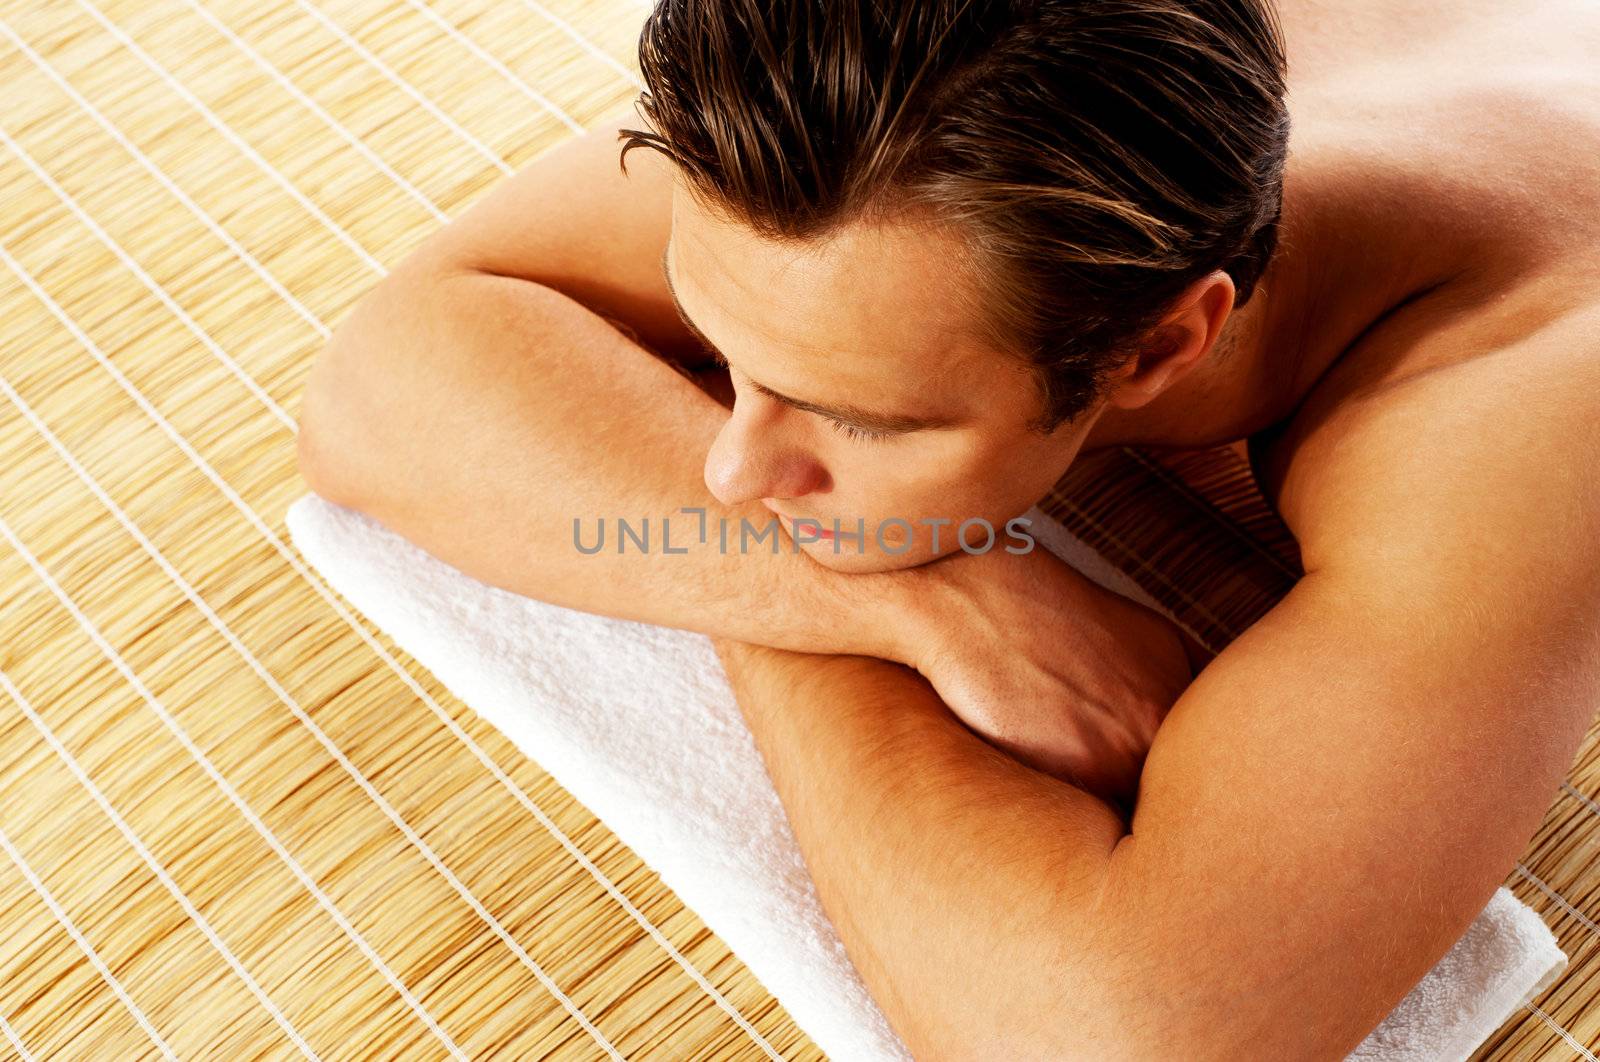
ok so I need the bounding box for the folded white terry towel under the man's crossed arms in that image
[286,494,1566,1062]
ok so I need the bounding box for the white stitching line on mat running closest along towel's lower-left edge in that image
[0,245,782,1059]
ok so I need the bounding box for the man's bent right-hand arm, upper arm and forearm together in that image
[717,321,1600,1059]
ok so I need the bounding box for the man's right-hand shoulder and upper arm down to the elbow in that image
[1096,294,1600,1057]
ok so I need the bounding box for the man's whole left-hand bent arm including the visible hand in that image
[299,115,1190,793]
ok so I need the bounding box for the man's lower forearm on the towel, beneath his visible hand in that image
[715,638,1128,1059]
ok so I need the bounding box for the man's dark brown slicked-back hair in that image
[619,0,1290,432]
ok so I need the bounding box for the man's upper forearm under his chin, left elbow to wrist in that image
[301,267,918,657]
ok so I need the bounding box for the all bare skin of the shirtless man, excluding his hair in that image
[299,0,1600,1059]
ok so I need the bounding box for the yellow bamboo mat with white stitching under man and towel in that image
[0,0,1600,1059]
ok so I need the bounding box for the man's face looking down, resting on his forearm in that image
[664,189,1094,571]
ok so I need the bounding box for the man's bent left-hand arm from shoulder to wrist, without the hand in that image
[299,115,925,659]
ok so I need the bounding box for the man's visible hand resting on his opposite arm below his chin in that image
[904,547,1194,811]
